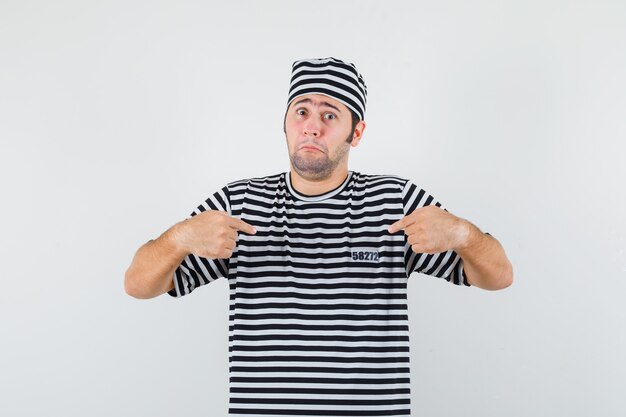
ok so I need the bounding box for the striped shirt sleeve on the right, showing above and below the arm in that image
[402,180,488,287]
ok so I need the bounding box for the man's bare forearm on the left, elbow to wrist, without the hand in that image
[124,221,189,299]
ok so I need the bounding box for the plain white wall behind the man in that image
[0,0,626,417]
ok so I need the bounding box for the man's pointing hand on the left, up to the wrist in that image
[175,210,256,259]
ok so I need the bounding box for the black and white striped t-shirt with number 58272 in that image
[169,171,469,417]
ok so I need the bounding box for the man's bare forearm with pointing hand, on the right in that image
[389,205,513,290]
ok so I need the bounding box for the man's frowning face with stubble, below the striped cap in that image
[285,94,358,180]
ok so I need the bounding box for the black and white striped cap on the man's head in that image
[287,57,367,120]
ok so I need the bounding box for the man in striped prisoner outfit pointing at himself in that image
[125,58,513,416]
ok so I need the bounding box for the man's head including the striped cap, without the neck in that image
[283,58,367,180]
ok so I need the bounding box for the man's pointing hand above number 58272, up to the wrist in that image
[388,205,470,254]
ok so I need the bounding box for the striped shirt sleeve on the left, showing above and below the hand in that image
[167,186,232,298]
